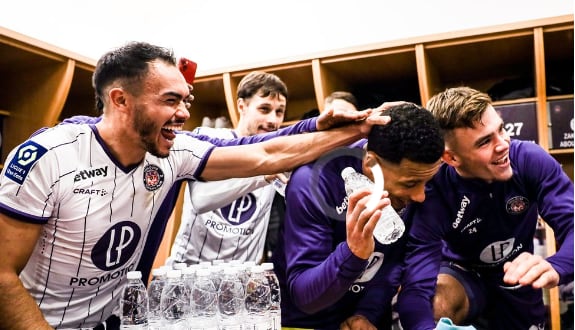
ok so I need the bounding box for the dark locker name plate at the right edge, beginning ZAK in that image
[547,99,573,149]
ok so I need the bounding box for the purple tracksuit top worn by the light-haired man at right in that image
[398,140,573,330]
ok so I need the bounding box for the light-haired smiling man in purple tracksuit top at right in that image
[398,87,573,330]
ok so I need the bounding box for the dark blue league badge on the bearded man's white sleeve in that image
[5,141,48,184]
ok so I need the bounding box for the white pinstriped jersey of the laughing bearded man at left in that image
[0,125,214,329]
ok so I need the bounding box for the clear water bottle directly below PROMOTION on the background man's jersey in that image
[218,267,245,330]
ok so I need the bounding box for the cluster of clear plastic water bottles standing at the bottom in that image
[121,261,281,330]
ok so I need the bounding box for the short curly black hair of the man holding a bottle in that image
[367,102,445,164]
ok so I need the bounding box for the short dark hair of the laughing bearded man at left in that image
[92,41,176,111]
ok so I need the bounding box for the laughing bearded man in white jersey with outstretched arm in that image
[0,42,389,330]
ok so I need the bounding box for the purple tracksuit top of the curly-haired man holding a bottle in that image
[273,140,405,329]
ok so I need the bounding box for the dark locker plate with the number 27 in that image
[494,102,539,143]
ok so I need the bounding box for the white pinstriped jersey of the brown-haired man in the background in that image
[166,127,275,265]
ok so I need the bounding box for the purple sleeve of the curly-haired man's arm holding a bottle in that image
[284,167,367,313]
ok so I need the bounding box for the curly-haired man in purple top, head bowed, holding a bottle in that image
[273,103,444,329]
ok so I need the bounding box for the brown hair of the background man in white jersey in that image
[237,71,288,100]
